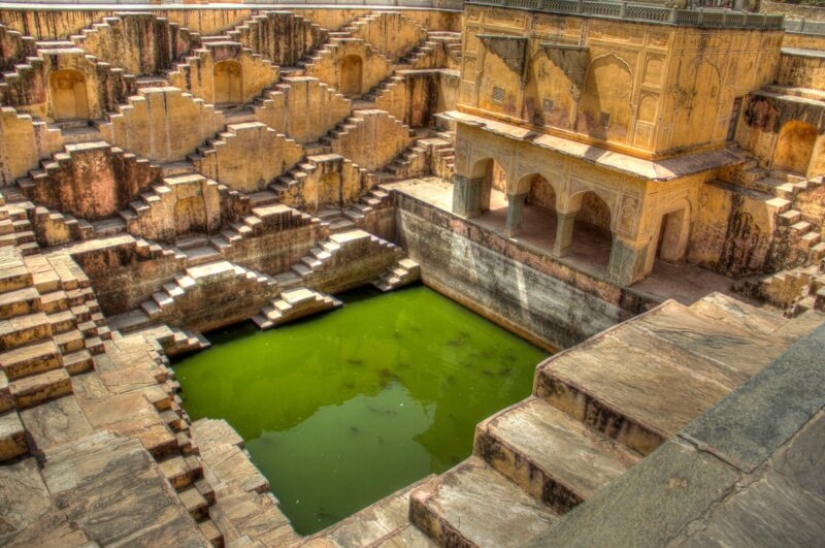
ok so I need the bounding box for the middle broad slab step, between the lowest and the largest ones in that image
[474,398,641,514]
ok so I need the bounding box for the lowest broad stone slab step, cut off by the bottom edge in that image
[410,457,558,548]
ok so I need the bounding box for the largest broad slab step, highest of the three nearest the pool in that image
[535,301,787,455]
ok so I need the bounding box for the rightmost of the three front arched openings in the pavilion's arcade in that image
[568,190,613,269]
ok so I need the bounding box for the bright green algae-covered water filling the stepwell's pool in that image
[175,287,546,534]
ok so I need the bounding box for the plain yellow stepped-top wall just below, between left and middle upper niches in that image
[100,87,225,162]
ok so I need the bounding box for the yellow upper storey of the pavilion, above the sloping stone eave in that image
[458,6,782,157]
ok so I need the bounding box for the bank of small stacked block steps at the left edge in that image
[0,246,111,460]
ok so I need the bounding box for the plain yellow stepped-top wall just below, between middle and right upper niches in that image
[253,77,352,144]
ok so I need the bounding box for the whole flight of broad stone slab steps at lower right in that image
[410,293,825,548]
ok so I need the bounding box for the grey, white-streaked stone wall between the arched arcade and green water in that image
[396,194,652,349]
